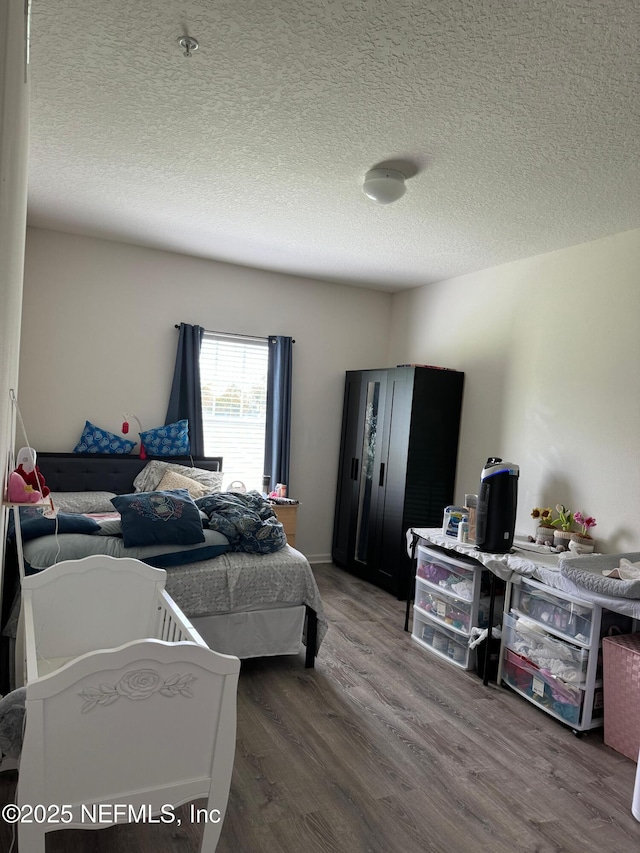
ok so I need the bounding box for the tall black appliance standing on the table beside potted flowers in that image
[476,456,520,554]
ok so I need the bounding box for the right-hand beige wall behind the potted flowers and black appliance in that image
[390,226,640,552]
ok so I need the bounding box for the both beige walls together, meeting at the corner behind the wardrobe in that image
[20,223,640,559]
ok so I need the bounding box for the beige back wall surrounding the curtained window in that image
[20,229,391,559]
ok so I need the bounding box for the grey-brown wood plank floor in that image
[0,565,640,853]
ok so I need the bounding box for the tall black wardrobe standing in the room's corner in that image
[332,367,464,599]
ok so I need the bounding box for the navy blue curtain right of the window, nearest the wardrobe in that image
[264,335,293,489]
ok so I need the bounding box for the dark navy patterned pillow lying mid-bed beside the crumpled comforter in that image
[111,489,205,548]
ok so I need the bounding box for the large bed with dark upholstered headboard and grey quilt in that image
[3,452,327,692]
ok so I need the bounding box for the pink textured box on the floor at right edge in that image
[602,634,640,761]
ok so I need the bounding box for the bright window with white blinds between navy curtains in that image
[200,332,269,491]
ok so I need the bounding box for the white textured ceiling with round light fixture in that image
[29,0,640,290]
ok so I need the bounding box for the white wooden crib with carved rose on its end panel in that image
[17,556,240,853]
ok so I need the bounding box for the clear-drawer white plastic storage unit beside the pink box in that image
[498,579,636,732]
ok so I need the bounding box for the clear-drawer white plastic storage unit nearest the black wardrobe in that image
[411,545,504,670]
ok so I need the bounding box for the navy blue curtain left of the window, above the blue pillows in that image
[165,323,204,456]
